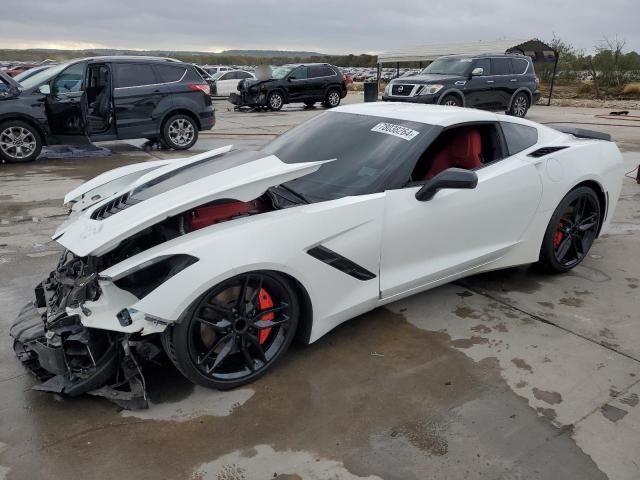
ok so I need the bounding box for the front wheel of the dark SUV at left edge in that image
[0,120,42,163]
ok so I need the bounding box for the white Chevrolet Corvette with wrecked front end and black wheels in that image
[11,103,623,408]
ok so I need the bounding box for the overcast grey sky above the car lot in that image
[0,0,640,54]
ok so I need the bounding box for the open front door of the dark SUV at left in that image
[40,62,91,145]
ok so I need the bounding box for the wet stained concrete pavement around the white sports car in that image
[0,96,640,480]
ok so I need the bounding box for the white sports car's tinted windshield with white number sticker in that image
[262,112,433,202]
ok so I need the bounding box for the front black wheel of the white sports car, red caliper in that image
[162,272,300,390]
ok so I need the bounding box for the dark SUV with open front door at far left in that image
[0,57,215,162]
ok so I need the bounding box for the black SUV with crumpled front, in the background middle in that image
[229,63,347,111]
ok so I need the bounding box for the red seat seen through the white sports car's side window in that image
[424,128,482,180]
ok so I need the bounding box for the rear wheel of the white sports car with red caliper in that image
[538,187,602,273]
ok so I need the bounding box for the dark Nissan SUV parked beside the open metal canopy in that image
[382,53,540,117]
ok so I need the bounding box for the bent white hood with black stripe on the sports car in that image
[53,147,330,257]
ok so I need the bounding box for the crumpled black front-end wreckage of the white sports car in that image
[9,252,161,409]
